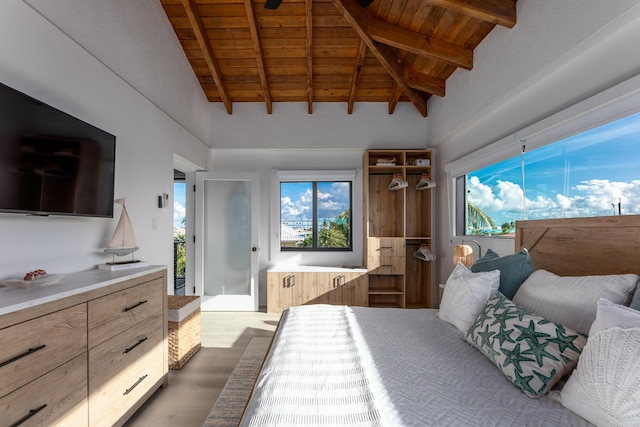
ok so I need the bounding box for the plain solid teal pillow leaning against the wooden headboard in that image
[471,249,534,299]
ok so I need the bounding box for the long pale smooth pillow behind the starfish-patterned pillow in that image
[513,270,640,334]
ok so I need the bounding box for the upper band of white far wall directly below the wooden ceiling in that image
[209,102,427,150]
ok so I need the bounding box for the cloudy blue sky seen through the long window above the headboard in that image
[467,113,640,227]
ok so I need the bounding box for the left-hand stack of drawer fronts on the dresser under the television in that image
[0,304,88,426]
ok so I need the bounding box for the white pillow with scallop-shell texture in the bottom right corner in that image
[560,301,640,427]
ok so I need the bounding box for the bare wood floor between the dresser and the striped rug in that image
[125,312,280,427]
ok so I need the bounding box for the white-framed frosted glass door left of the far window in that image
[195,172,259,311]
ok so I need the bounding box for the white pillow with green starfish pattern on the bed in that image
[465,292,587,398]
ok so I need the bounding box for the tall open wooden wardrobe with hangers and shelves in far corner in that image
[363,150,437,308]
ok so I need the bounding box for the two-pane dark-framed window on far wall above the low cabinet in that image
[280,180,353,251]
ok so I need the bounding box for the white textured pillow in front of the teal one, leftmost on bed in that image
[438,263,500,332]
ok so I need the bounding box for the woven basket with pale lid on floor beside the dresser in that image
[167,295,201,369]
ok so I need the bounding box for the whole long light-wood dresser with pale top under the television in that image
[0,268,168,427]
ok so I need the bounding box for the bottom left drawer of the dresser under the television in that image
[0,353,89,427]
